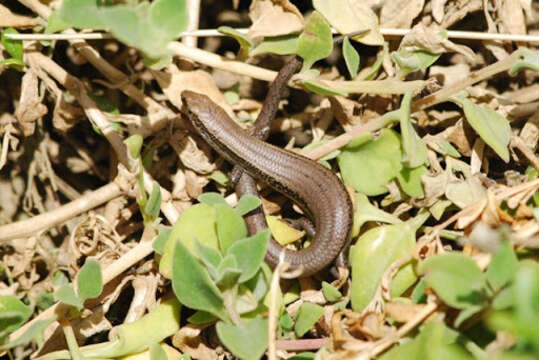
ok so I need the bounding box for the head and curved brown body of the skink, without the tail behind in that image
[182,91,353,277]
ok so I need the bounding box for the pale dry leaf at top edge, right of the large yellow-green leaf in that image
[380,0,425,29]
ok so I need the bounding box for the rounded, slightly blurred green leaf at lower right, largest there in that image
[418,253,485,309]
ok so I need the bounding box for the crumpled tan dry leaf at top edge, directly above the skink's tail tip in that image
[248,0,303,39]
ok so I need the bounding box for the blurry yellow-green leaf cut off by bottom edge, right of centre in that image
[379,322,473,360]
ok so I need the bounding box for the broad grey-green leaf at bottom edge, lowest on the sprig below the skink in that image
[216,318,268,360]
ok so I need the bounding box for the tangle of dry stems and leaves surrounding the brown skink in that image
[0,0,539,359]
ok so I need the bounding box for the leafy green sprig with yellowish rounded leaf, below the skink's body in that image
[160,193,271,359]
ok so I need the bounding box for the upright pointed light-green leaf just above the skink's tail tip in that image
[297,11,333,72]
